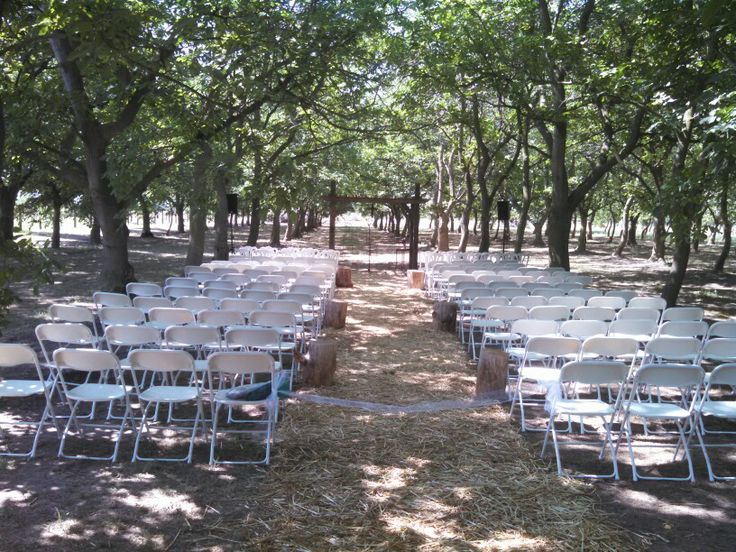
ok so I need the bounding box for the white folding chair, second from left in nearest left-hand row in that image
[54,348,136,462]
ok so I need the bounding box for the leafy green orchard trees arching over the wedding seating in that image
[0,0,736,304]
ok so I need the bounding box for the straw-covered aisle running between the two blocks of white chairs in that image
[249,273,628,550]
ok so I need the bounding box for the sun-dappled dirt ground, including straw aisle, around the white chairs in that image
[0,218,736,550]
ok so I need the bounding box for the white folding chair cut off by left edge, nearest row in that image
[0,343,59,458]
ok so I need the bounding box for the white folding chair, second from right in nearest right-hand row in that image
[616,364,703,481]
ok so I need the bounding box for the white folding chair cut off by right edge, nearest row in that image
[697,362,736,481]
